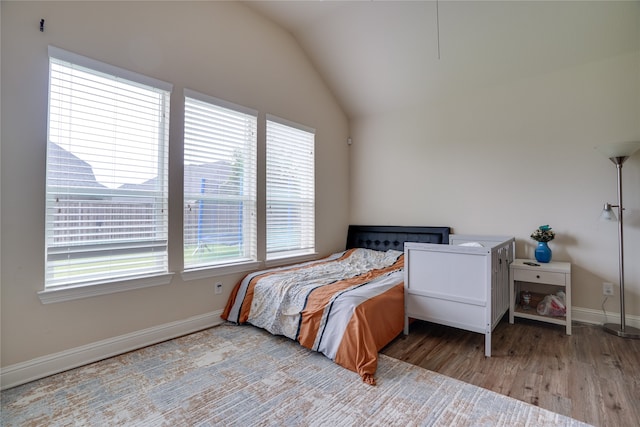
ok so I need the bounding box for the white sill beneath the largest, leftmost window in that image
[38,273,173,304]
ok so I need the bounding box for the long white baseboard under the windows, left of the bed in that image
[0,310,223,390]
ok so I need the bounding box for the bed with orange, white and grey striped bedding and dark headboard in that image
[222,225,450,385]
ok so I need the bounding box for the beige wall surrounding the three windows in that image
[0,1,349,368]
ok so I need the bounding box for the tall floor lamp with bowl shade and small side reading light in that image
[597,141,640,339]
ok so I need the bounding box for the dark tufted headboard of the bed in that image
[347,225,450,251]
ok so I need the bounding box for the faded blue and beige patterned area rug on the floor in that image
[0,324,585,426]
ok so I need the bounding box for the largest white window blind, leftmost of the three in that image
[45,47,171,289]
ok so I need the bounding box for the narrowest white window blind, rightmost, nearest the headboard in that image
[267,115,315,259]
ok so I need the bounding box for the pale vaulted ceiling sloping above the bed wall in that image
[245,0,640,118]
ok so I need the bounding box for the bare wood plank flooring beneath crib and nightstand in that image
[382,317,640,427]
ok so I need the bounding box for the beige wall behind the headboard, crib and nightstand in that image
[350,49,640,326]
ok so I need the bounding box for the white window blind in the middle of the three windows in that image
[184,90,258,270]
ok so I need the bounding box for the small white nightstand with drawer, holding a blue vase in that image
[509,259,571,335]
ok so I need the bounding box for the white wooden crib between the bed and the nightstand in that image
[404,234,515,357]
